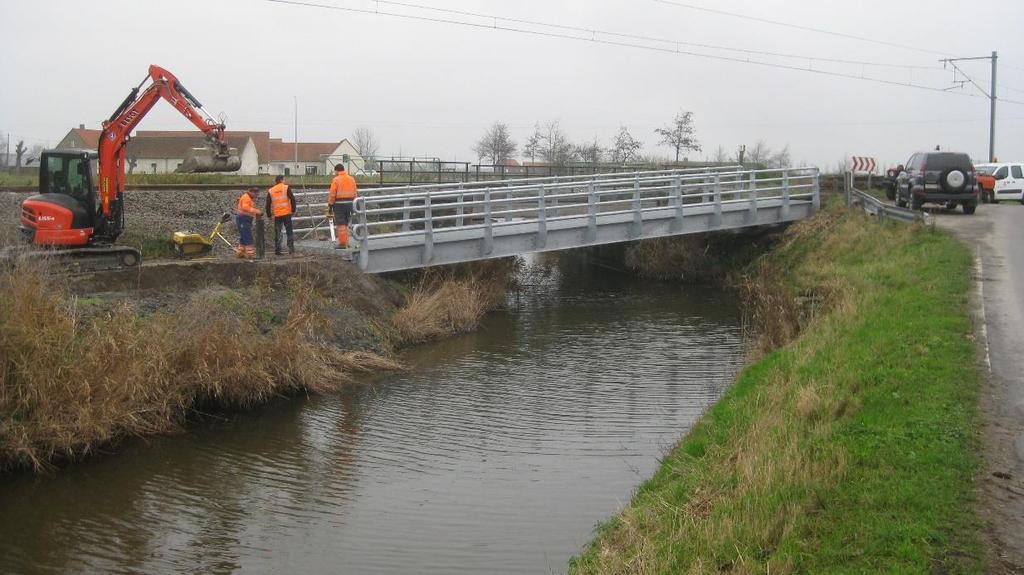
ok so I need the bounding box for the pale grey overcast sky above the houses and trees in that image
[0,0,1024,168]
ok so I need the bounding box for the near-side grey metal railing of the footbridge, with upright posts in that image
[354,168,820,261]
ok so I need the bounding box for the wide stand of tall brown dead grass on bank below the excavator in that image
[0,258,396,471]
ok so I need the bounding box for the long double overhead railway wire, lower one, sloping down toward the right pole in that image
[265,0,1024,105]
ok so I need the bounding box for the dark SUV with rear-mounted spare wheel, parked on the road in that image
[896,151,978,214]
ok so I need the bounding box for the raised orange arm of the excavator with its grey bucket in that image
[97,65,242,239]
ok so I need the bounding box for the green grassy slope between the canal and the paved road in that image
[572,207,984,573]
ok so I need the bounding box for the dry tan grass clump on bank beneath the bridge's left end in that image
[392,260,518,344]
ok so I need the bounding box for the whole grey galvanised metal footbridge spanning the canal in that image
[295,167,820,273]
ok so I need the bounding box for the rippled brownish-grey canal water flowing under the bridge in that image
[0,255,741,574]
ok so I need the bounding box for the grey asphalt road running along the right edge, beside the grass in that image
[935,203,1024,573]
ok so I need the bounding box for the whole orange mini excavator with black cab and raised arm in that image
[20,65,242,269]
